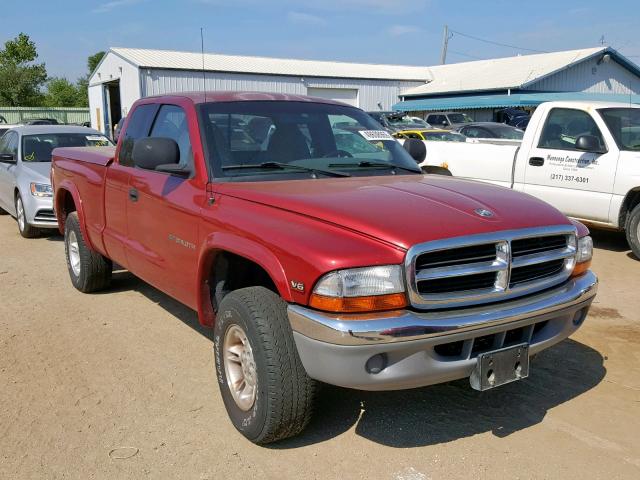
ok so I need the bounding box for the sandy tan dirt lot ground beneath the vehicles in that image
[0,216,640,480]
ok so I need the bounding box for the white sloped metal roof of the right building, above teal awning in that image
[402,47,640,97]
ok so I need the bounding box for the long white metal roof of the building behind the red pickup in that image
[110,47,429,82]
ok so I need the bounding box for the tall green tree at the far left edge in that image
[0,33,47,107]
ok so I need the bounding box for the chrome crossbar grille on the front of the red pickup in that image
[405,226,576,309]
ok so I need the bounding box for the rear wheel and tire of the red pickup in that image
[64,212,113,293]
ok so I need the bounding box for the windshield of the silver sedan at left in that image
[22,132,113,162]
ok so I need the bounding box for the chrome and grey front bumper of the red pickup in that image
[288,271,598,390]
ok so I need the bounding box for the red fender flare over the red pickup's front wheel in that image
[196,232,292,326]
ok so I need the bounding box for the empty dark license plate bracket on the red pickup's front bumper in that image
[469,343,529,391]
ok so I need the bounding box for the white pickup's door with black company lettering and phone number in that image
[520,108,618,222]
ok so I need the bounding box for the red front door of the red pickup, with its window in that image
[127,104,204,306]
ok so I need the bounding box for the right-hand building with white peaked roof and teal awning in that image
[394,47,640,120]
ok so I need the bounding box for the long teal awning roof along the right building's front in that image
[393,92,640,112]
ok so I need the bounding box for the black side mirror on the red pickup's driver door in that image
[132,137,191,176]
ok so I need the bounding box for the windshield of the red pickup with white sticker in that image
[199,101,421,181]
